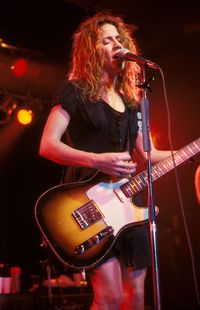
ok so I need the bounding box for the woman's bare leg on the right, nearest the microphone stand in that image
[120,267,147,310]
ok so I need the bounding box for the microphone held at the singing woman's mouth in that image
[113,48,159,70]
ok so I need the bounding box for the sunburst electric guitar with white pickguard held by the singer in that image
[35,138,200,269]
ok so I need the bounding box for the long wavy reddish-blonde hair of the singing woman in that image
[68,12,140,106]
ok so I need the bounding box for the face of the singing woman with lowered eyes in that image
[100,24,123,72]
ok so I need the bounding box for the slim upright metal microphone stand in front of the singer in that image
[139,66,161,310]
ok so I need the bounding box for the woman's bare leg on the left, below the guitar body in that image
[89,257,122,310]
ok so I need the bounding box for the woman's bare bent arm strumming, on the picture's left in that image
[39,105,136,176]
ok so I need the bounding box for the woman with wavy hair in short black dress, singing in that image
[40,13,171,310]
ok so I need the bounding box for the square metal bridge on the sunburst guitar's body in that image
[72,200,103,229]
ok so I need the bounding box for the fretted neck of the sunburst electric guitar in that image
[120,138,200,198]
